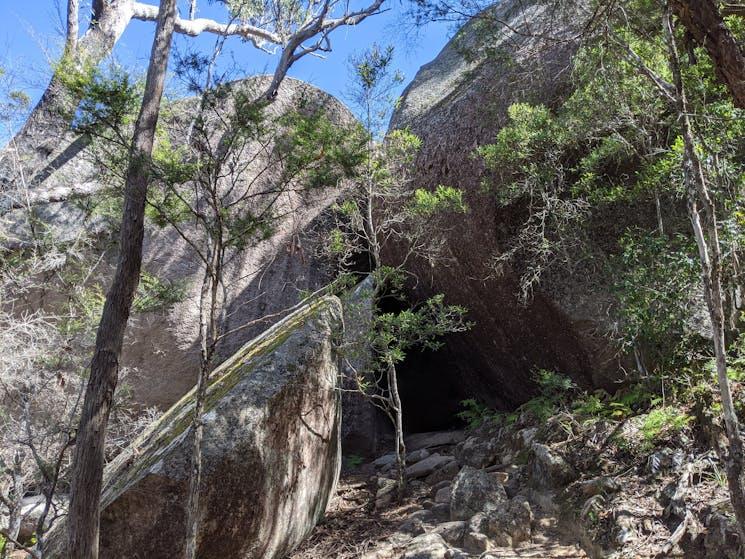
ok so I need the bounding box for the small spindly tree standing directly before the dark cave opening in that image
[329,45,467,495]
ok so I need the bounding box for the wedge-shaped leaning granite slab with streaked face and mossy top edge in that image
[48,297,343,559]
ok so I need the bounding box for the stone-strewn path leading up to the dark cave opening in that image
[291,431,588,559]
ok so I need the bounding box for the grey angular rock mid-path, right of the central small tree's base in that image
[450,466,507,520]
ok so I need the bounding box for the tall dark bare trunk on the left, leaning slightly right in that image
[68,0,176,559]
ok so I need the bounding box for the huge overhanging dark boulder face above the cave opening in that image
[387,1,617,407]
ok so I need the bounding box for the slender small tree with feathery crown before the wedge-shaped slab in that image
[142,76,359,558]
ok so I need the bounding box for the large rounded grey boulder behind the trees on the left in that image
[0,76,356,409]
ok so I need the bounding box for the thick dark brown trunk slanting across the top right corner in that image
[672,0,745,108]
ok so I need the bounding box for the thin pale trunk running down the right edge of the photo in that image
[665,7,745,534]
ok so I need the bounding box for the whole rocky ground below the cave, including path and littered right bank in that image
[290,406,739,559]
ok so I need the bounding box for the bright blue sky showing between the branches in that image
[0,0,451,117]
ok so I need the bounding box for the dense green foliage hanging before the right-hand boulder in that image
[475,0,745,371]
